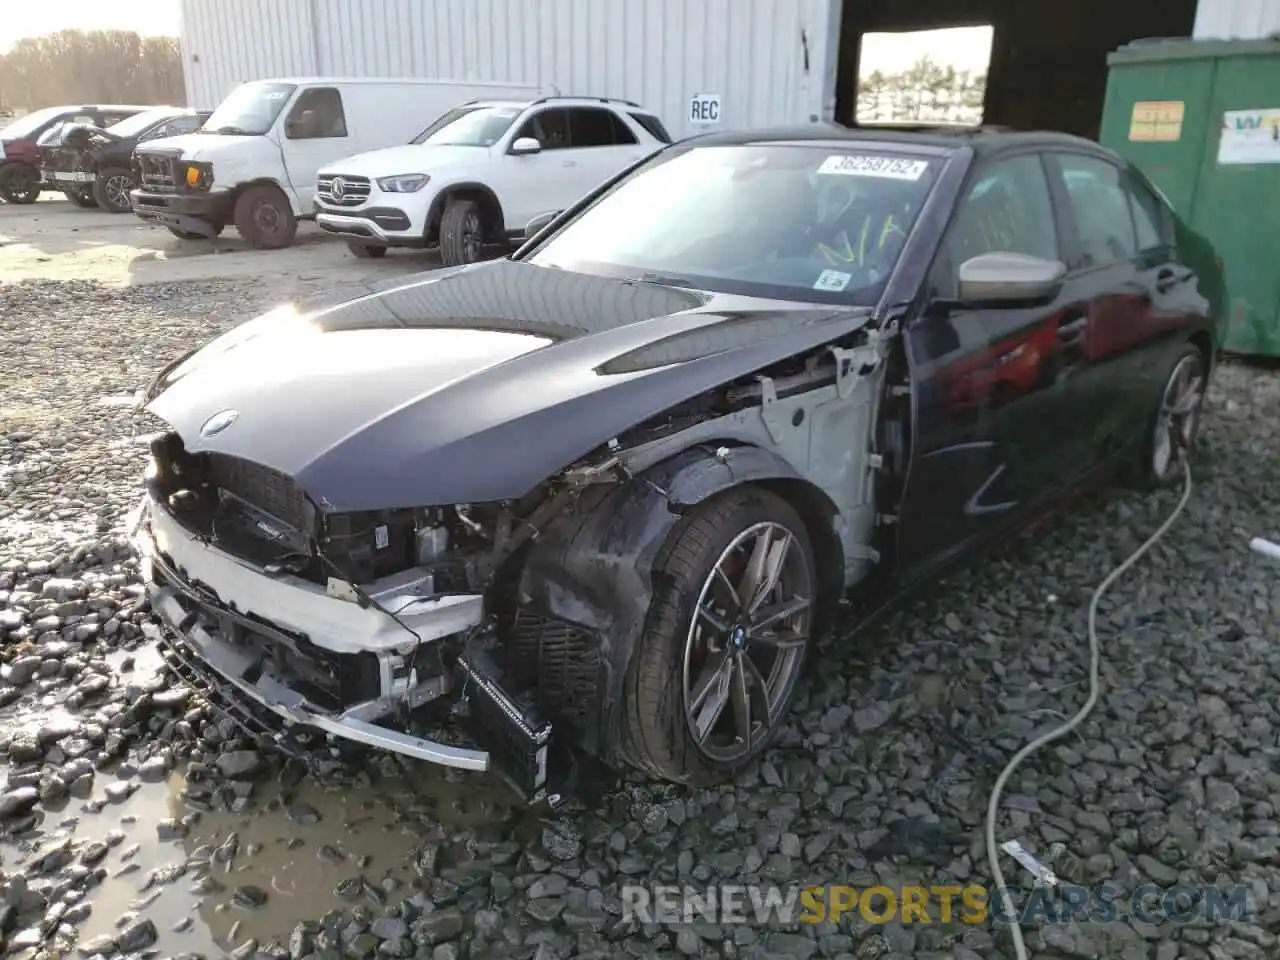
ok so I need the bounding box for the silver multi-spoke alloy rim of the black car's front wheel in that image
[684,522,813,763]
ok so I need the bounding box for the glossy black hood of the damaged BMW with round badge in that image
[147,261,870,511]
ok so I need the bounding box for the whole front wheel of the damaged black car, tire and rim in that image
[620,486,817,785]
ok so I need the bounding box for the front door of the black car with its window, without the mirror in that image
[897,146,1083,579]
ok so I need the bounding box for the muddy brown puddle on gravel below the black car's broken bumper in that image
[78,772,509,956]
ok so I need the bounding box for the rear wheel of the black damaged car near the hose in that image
[1132,343,1207,490]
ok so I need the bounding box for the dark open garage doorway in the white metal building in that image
[836,0,1196,138]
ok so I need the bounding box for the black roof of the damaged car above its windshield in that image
[682,123,1111,155]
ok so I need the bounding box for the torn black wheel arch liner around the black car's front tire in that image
[520,444,835,762]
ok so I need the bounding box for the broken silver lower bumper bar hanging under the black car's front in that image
[134,512,556,803]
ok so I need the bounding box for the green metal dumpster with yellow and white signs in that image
[1100,40,1280,357]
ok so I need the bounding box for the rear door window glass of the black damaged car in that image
[1059,154,1138,268]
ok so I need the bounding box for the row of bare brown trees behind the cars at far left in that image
[0,29,187,110]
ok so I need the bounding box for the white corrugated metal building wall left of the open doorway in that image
[182,0,840,136]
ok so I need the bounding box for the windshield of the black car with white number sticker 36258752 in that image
[529,145,937,303]
